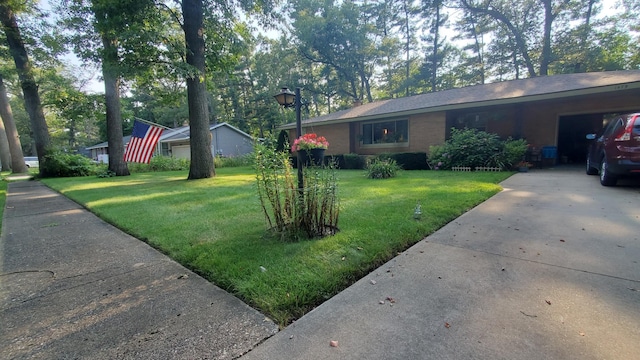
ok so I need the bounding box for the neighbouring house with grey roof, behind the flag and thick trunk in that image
[86,123,254,163]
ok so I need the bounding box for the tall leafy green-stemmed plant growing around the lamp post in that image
[254,144,339,241]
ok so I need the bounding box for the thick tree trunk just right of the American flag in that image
[182,0,216,180]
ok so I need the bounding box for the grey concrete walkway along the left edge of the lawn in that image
[0,181,277,359]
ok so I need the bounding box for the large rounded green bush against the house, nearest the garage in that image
[428,129,527,170]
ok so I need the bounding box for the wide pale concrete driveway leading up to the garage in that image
[241,168,640,360]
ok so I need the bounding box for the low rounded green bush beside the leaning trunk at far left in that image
[40,151,97,177]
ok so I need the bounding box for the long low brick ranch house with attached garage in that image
[281,70,640,163]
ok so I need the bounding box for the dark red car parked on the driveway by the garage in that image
[587,113,640,186]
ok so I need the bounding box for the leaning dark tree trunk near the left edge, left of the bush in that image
[0,2,51,175]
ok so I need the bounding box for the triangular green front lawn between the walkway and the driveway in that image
[42,168,511,325]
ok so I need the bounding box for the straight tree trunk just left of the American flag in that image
[102,34,130,176]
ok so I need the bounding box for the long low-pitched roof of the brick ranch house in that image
[281,70,640,129]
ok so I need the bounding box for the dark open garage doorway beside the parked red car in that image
[558,114,604,164]
